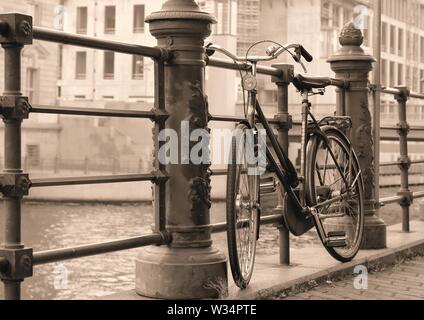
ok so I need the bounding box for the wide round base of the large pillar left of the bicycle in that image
[136,246,228,300]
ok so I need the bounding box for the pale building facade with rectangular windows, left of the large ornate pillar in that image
[58,0,162,107]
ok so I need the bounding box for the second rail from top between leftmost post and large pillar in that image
[31,106,157,120]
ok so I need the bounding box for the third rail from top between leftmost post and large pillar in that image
[31,174,159,188]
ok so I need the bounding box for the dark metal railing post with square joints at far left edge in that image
[0,14,32,300]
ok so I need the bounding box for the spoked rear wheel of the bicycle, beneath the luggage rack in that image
[306,127,364,262]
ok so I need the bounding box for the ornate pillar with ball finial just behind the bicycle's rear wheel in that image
[328,23,386,249]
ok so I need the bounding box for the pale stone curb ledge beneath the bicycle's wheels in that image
[104,221,424,300]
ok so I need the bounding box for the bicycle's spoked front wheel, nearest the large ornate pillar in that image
[226,124,260,289]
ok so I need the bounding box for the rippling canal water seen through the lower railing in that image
[0,188,419,299]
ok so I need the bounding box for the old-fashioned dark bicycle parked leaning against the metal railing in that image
[206,41,364,289]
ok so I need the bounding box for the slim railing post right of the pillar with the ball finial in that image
[395,87,414,232]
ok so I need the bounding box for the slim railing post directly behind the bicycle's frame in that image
[272,63,294,266]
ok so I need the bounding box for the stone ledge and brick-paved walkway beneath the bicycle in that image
[101,221,424,300]
